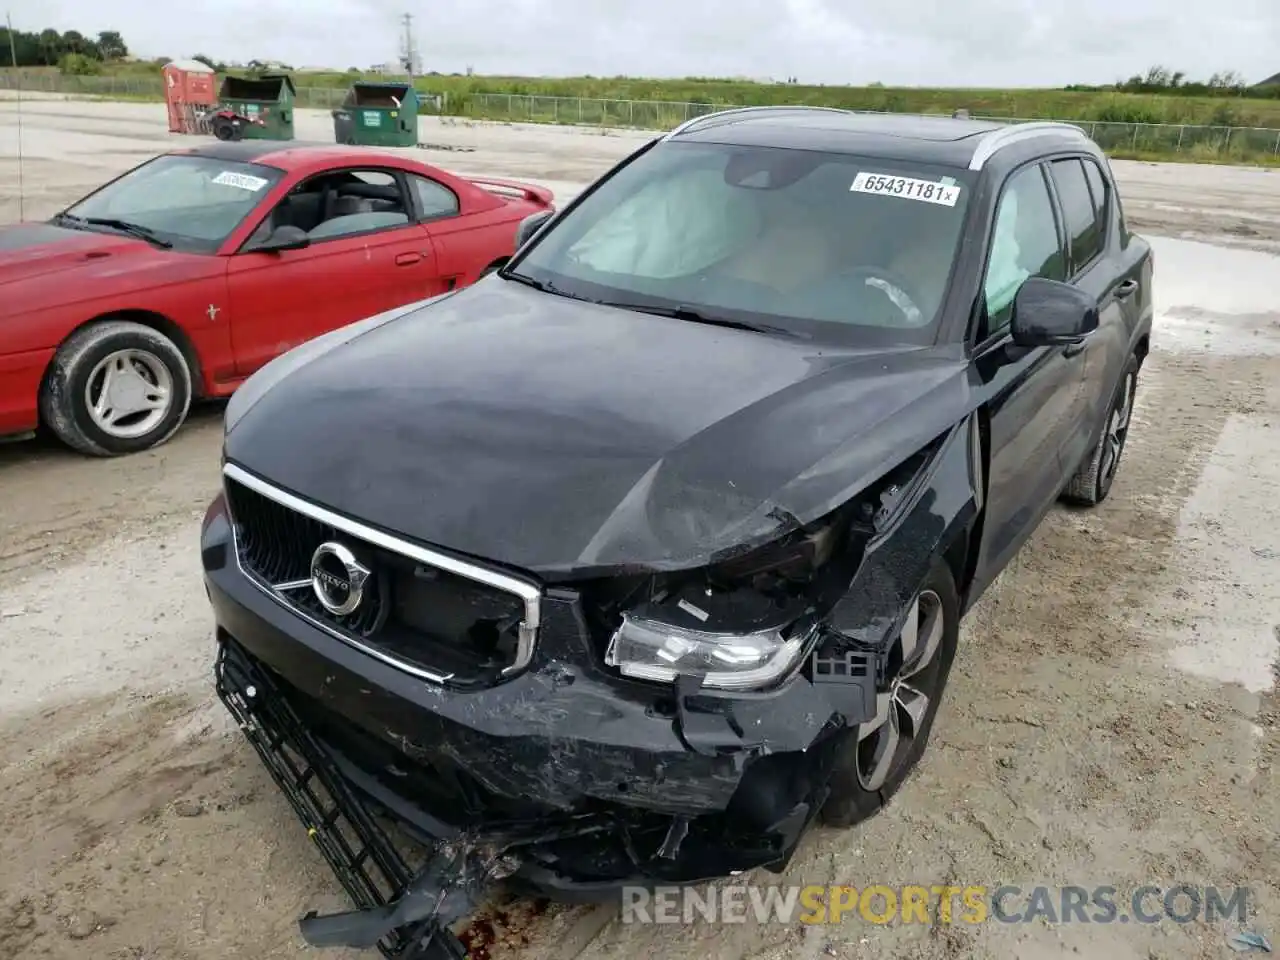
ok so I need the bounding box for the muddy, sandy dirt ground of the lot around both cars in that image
[0,100,1280,960]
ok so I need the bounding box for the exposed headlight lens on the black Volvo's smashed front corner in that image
[604,613,804,690]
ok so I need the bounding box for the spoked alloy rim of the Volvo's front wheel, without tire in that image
[856,590,946,792]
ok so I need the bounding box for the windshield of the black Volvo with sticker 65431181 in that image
[512,142,972,344]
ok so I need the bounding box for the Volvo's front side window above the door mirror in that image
[983,165,1066,335]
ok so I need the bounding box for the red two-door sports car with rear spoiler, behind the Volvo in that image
[0,141,553,456]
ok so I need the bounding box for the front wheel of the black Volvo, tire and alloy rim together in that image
[822,559,960,827]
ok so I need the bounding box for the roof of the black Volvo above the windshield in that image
[667,106,1084,168]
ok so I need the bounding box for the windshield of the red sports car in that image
[65,156,283,252]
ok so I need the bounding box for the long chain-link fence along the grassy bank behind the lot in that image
[0,73,1280,161]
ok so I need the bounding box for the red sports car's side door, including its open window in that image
[227,168,447,376]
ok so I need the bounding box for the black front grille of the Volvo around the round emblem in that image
[225,477,525,686]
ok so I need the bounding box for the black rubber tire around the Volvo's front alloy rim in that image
[819,559,960,827]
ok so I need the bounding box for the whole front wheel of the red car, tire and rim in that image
[40,320,192,457]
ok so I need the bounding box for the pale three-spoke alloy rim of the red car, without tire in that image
[84,349,174,440]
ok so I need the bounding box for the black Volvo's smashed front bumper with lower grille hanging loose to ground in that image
[202,504,876,959]
